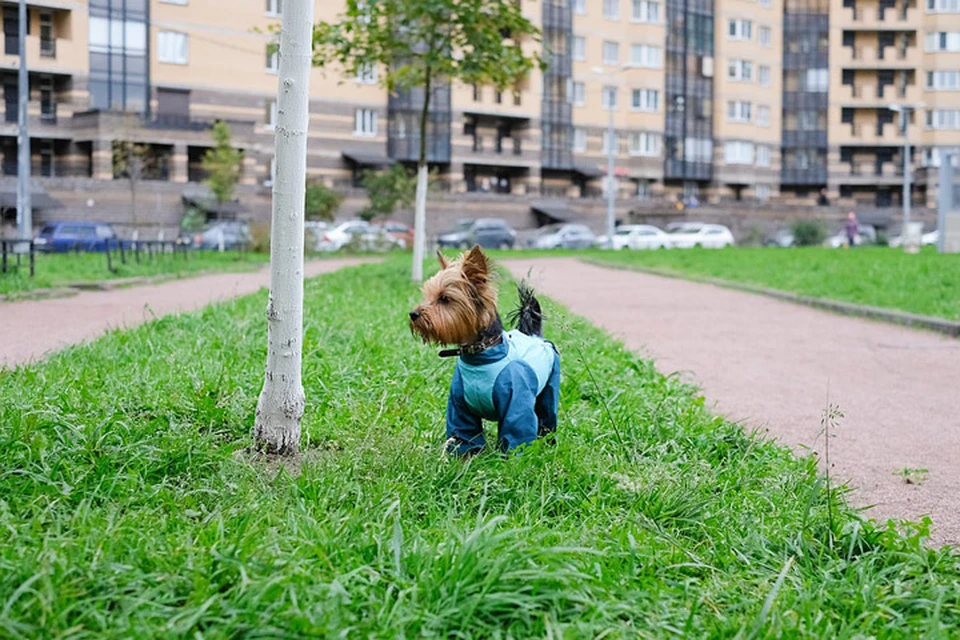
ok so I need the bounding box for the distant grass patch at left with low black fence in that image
[0,251,269,295]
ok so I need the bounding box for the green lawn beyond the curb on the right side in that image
[588,247,960,320]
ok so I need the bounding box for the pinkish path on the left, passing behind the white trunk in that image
[0,259,372,368]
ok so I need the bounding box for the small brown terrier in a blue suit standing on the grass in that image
[410,247,560,456]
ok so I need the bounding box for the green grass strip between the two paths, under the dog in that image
[0,257,960,638]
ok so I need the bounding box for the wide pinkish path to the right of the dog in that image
[506,258,960,544]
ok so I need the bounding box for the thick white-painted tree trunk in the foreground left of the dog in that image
[253,0,314,455]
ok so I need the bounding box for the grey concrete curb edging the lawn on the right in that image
[580,258,960,338]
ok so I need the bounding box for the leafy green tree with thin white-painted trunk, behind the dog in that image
[314,0,540,282]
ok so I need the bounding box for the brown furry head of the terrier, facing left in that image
[410,246,497,344]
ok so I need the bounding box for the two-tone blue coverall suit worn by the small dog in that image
[447,331,560,454]
